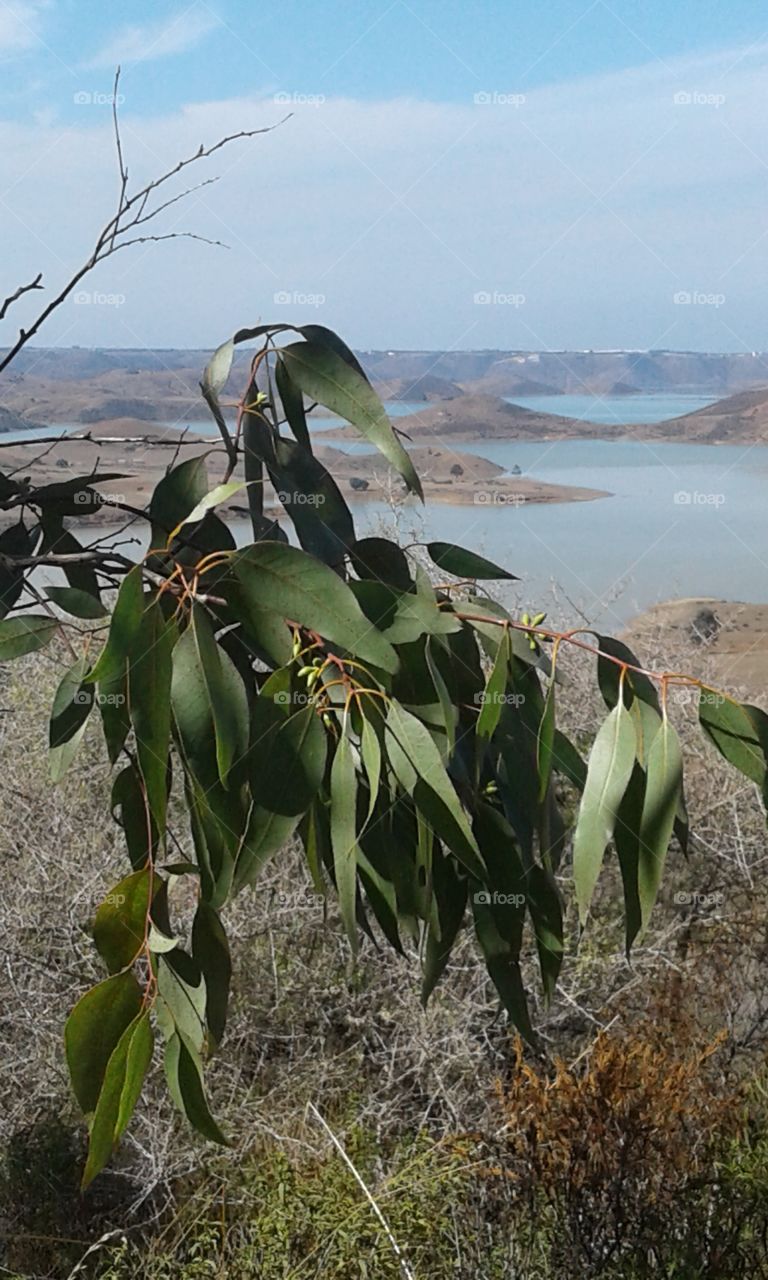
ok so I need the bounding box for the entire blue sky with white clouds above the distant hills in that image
[0,0,768,351]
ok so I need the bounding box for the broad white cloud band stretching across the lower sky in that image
[0,47,768,349]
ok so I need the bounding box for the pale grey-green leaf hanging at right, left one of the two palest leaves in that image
[573,701,636,924]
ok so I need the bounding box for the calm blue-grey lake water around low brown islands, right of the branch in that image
[12,396,768,627]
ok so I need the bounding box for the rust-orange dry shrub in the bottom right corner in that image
[486,983,768,1280]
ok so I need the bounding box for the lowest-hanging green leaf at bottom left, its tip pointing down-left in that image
[81,1010,154,1190]
